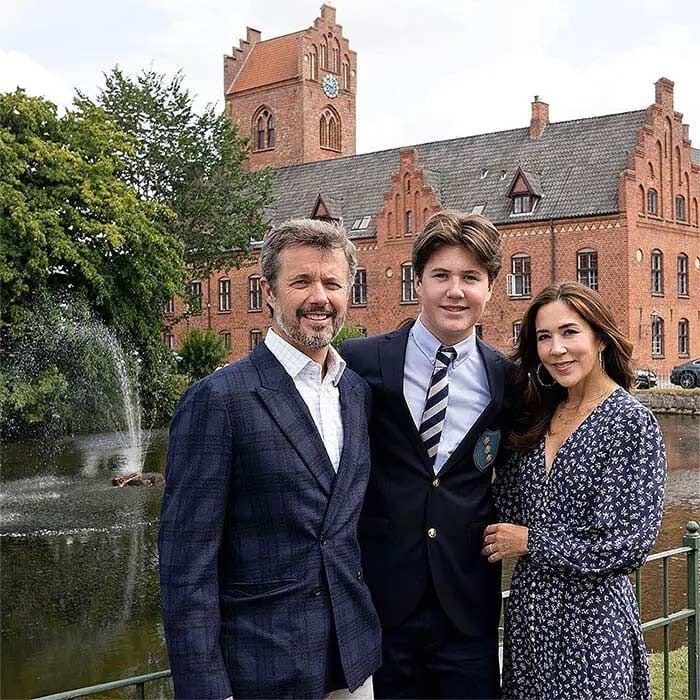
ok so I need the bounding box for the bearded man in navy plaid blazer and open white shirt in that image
[159,220,380,700]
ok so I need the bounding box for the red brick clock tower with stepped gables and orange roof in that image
[224,5,357,169]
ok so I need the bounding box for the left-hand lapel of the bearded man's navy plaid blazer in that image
[250,343,335,496]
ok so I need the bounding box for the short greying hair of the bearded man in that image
[260,219,357,290]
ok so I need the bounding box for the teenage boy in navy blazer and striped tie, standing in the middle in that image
[342,211,509,698]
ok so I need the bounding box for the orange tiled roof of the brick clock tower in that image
[228,32,301,95]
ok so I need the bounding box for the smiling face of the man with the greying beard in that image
[261,246,349,360]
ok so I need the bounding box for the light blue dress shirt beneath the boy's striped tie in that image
[403,316,491,474]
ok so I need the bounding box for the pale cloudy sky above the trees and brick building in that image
[0,0,700,153]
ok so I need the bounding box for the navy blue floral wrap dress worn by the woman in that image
[494,388,666,700]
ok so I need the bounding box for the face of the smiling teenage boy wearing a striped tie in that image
[416,245,491,345]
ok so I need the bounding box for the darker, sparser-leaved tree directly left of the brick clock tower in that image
[81,67,272,277]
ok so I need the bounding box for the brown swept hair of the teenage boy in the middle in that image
[413,209,503,283]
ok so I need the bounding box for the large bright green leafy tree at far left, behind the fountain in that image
[0,90,185,434]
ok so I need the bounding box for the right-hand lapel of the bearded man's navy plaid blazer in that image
[325,370,367,522]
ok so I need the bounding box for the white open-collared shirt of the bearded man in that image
[265,328,345,472]
